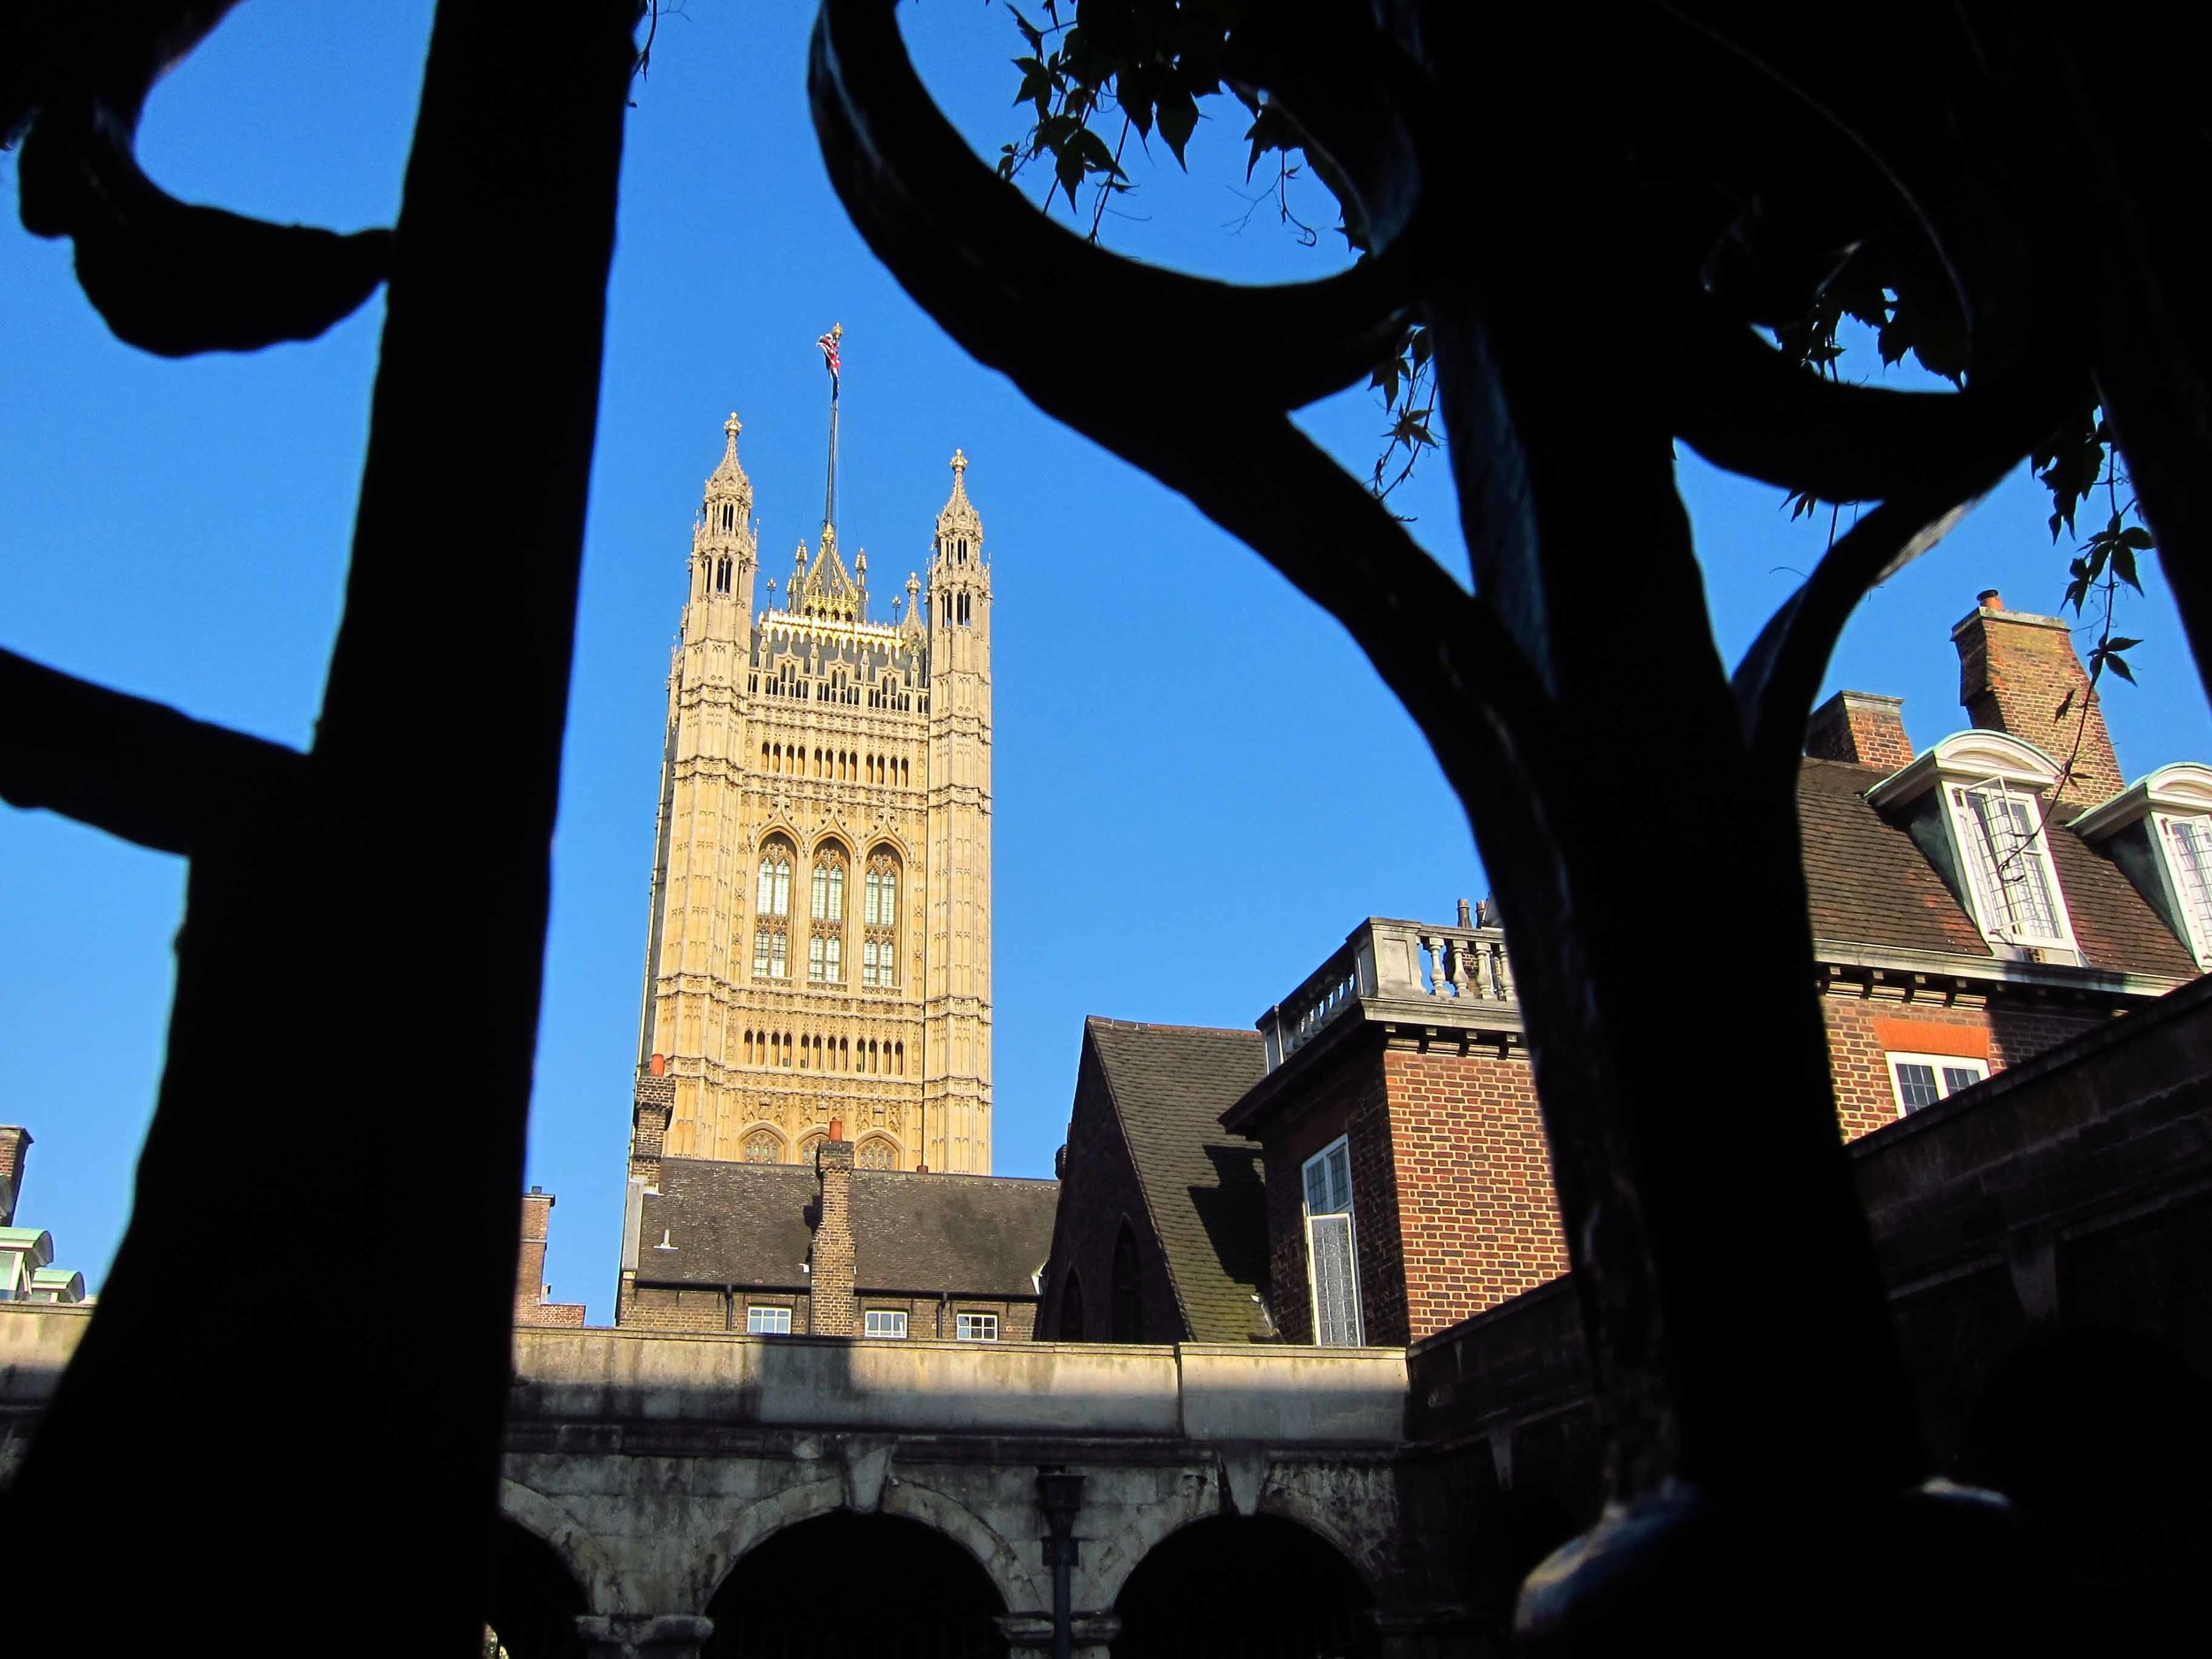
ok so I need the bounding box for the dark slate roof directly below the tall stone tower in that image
[637,1157,1060,1299]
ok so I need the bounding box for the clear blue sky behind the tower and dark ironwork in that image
[0,0,2212,1321]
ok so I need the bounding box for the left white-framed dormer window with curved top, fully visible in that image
[1867,730,2082,963]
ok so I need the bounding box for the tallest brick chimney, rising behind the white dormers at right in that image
[1951,588,2124,805]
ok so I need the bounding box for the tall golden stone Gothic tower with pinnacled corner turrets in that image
[631,416,991,1179]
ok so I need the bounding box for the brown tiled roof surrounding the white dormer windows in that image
[1799,759,2197,978]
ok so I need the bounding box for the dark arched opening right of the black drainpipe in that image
[1113,1516,1376,1659]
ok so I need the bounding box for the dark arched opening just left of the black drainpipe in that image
[702,1511,1007,1659]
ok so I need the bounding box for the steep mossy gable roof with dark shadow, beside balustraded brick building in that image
[1084,1016,1268,1343]
